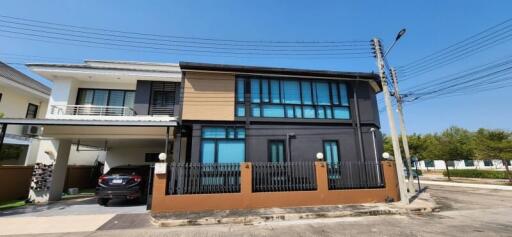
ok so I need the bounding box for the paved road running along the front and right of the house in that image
[12,185,512,237]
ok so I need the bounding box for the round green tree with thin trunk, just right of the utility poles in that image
[432,126,475,180]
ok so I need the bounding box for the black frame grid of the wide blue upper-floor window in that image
[235,76,352,120]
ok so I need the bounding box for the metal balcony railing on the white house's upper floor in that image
[50,105,137,116]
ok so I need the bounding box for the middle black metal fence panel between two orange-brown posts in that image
[252,162,317,192]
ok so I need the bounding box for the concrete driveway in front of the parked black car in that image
[0,198,151,235]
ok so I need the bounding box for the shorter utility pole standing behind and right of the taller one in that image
[390,67,414,193]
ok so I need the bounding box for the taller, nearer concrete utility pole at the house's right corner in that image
[372,38,409,204]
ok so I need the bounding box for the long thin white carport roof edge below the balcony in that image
[0,118,177,127]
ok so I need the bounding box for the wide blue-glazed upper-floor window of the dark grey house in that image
[236,78,350,119]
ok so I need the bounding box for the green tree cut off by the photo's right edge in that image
[473,128,512,183]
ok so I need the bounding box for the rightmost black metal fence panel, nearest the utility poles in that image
[327,161,384,189]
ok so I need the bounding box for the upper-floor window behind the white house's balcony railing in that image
[76,88,135,108]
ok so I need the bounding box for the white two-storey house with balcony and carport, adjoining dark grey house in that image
[5,60,182,203]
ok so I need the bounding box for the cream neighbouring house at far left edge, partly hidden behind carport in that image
[0,62,105,165]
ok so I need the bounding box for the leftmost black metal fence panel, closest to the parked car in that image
[168,163,240,194]
